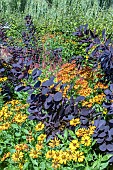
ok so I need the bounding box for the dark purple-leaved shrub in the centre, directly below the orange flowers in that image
[15,69,100,138]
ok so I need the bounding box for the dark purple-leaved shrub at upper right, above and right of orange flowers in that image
[73,24,113,82]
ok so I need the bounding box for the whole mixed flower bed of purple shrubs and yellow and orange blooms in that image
[0,15,113,170]
